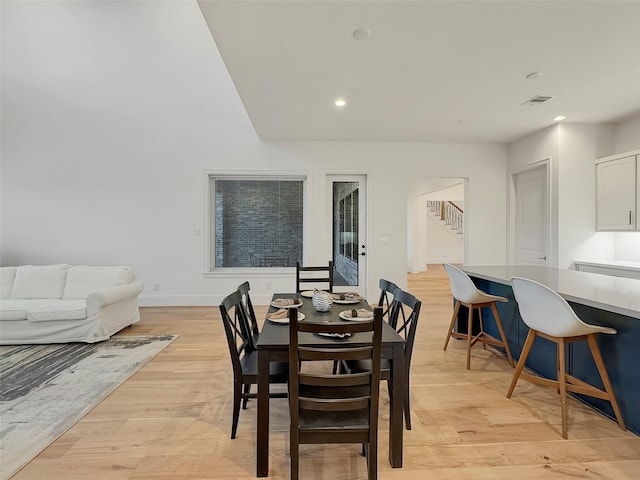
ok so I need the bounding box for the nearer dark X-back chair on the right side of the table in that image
[342,288,422,430]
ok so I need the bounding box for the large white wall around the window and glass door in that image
[0,1,507,305]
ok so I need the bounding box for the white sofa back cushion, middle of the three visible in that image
[9,265,69,299]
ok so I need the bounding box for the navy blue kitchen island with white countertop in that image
[458,265,640,435]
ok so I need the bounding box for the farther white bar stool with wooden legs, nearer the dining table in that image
[444,263,514,370]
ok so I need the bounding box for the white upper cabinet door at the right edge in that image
[596,156,637,230]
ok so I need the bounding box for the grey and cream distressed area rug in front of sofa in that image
[0,336,177,480]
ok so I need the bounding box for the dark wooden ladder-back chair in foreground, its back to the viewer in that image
[289,308,382,480]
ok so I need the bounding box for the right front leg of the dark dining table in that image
[389,345,406,468]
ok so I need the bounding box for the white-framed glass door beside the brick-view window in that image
[327,175,367,296]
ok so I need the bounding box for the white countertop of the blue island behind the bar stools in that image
[462,265,640,318]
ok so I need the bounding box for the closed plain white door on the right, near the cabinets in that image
[515,164,549,265]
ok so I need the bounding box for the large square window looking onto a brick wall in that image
[209,176,304,270]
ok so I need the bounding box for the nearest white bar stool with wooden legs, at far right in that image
[507,277,626,439]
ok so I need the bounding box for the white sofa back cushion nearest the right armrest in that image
[62,266,133,300]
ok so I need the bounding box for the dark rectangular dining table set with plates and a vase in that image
[256,292,406,477]
